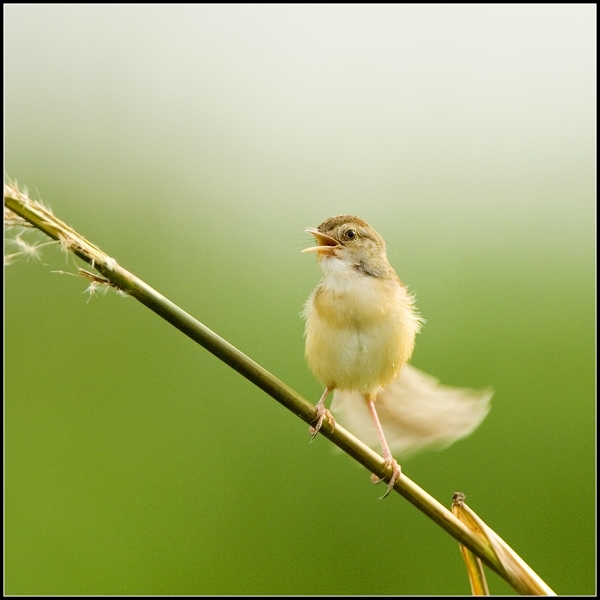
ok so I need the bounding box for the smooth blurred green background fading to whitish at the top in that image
[4,4,596,595]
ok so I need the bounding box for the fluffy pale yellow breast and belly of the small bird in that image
[304,262,419,394]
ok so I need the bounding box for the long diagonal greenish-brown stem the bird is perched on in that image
[4,183,553,594]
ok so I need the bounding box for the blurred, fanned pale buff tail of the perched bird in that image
[331,365,493,457]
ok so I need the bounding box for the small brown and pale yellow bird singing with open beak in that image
[302,215,493,498]
